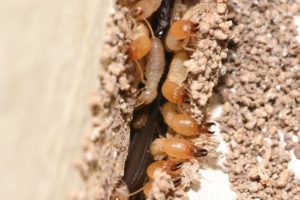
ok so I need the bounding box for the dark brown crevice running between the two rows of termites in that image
[122,0,174,200]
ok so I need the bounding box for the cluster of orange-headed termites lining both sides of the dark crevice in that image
[124,0,213,196]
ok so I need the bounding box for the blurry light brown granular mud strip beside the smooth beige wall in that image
[78,7,135,199]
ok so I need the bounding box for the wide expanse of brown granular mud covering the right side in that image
[219,0,300,200]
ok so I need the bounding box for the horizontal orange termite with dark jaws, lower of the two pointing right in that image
[150,137,208,161]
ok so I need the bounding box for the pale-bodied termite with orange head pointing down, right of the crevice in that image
[162,51,189,105]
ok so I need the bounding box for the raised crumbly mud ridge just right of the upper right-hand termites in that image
[184,0,234,121]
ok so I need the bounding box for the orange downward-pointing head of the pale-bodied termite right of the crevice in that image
[162,79,185,105]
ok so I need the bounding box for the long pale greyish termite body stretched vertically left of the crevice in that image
[136,37,165,107]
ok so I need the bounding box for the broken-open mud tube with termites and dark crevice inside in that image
[75,0,232,199]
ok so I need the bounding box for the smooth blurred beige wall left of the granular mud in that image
[0,0,112,200]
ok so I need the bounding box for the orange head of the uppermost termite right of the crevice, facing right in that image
[170,20,198,40]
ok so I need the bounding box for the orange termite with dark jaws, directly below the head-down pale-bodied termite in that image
[161,102,214,136]
